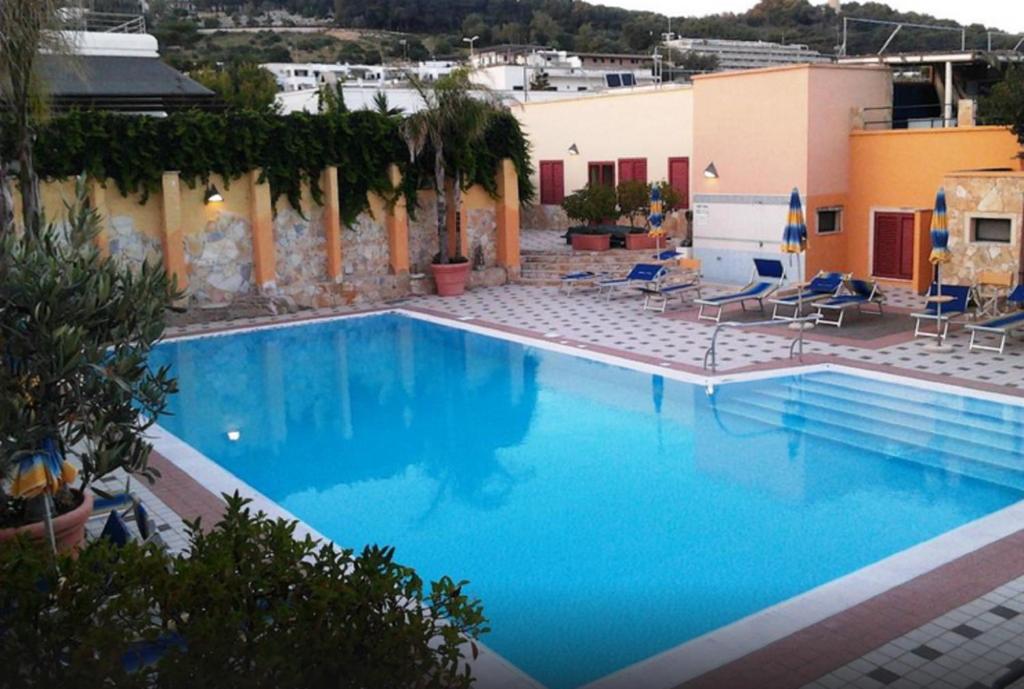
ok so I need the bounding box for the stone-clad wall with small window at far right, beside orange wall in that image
[943,173,1024,285]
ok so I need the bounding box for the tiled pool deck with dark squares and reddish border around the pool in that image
[134,286,1024,689]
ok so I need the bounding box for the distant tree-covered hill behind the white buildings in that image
[163,0,1017,64]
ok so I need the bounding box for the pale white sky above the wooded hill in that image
[591,0,1024,33]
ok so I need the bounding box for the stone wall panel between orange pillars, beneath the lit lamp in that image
[184,213,253,303]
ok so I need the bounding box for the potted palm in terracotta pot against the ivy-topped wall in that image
[401,70,500,297]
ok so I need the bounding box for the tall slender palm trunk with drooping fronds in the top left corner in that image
[0,0,70,231]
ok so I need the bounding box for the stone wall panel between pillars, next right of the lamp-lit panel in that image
[273,203,328,306]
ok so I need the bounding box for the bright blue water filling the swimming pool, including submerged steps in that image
[153,314,1024,689]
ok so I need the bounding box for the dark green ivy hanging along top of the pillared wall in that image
[0,111,534,224]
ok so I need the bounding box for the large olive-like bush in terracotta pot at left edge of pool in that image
[0,176,180,551]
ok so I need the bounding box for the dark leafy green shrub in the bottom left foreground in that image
[0,494,487,689]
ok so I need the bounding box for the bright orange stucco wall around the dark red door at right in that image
[843,127,1020,287]
